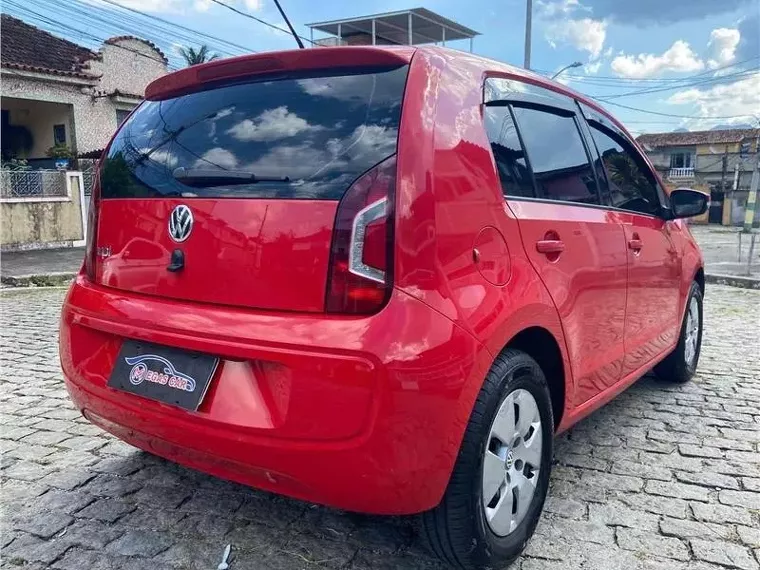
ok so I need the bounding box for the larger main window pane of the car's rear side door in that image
[513,106,600,204]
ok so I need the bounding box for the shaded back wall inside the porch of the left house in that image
[2,93,74,158]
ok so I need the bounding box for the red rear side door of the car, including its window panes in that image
[485,79,627,405]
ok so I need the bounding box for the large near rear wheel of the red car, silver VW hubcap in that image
[421,349,554,570]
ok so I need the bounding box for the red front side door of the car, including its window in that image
[583,107,681,375]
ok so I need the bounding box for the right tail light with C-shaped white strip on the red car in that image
[325,155,396,314]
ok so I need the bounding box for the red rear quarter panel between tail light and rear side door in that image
[395,50,573,422]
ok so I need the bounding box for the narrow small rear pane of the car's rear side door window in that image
[485,105,534,198]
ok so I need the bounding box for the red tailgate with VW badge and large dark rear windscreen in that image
[96,63,408,312]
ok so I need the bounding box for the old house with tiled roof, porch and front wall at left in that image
[0,14,168,251]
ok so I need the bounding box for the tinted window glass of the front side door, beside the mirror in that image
[589,120,660,215]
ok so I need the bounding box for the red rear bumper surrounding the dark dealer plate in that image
[61,277,490,514]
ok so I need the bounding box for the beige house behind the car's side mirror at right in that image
[636,129,760,225]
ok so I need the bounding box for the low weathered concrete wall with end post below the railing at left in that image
[0,172,86,251]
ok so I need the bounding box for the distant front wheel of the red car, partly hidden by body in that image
[654,281,703,384]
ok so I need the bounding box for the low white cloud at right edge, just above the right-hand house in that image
[666,75,760,128]
